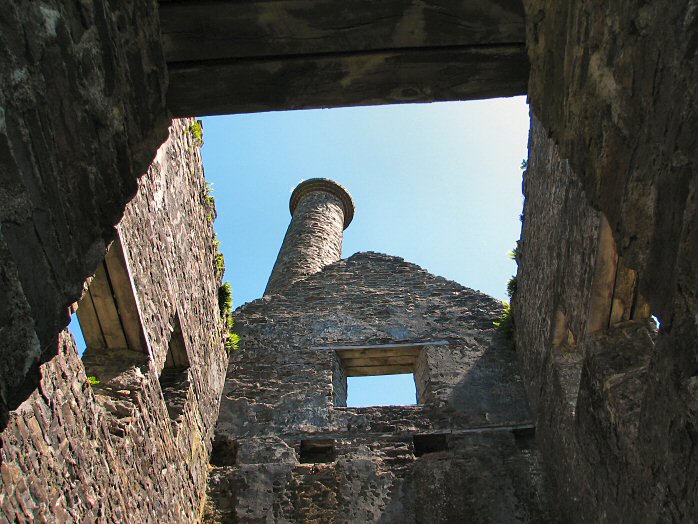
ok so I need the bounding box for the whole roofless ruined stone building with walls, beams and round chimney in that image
[0,0,698,523]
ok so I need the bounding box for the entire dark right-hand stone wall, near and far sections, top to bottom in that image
[516,0,698,522]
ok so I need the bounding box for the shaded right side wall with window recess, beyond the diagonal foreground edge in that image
[514,113,696,522]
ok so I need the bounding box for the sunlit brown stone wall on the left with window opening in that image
[0,120,227,522]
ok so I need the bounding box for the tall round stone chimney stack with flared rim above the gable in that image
[264,178,354,295]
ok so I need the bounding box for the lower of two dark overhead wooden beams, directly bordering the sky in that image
[168,44,529,116]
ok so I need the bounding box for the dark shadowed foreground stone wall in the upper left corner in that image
[0,0,168,422]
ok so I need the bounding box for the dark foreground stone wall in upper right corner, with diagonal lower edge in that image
[524,4,698,314]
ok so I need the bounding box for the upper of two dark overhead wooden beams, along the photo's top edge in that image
[160,0,526,63]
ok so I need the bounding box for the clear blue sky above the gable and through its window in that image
[71,97,529,405]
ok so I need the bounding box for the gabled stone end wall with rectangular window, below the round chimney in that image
[207,253,555,522]
